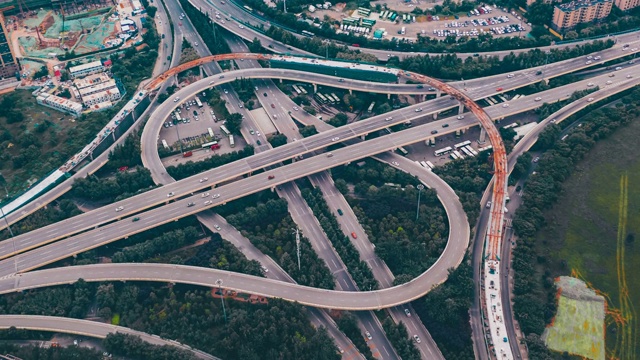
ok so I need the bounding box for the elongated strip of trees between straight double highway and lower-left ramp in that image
[111,226,204,263]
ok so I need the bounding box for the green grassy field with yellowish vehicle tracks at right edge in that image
[537,114,640,359]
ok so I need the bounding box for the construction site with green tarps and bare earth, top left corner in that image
[5,0,137,59]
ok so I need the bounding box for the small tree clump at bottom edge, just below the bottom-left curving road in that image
[102,333,198,360]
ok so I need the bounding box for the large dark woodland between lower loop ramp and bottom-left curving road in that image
[0,280,340,360]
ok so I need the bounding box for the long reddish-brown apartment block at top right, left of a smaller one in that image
[553,0,613,30]
